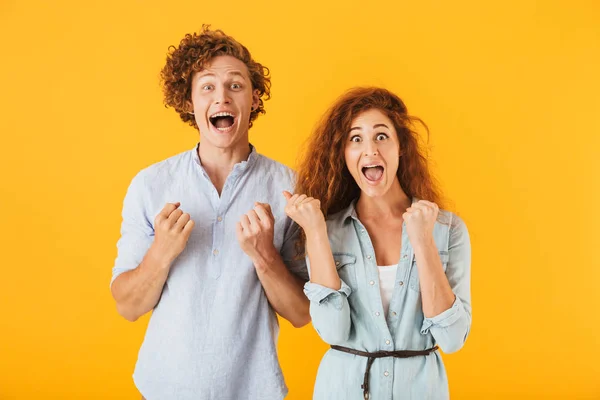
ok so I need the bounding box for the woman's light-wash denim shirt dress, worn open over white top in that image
[304,203,471,400]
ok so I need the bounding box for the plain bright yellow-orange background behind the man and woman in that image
[0,0,600,400]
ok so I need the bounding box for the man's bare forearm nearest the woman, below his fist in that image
[254,251,310,328]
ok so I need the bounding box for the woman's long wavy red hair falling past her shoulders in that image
[295,87,442,222]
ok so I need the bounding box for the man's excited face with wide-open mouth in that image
[191,56,259,149]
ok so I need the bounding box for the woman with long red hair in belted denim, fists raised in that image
[285,88,471,400]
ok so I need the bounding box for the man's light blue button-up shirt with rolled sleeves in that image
[111,147,308,400]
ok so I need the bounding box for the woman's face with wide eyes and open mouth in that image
[344,109,400,197]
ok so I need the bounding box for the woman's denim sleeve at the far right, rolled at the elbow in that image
[421,215,471,353]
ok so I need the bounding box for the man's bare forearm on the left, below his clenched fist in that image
[111,248,170,322]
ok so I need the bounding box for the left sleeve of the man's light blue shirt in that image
[110,171,154,286]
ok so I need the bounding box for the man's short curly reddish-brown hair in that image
[160,25,271,129]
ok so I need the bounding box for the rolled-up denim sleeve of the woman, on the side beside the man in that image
[304,257,352,344]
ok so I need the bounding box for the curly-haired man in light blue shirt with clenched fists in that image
[111,26,310,400]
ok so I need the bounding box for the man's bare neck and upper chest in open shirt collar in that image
[198,140,250,196]
